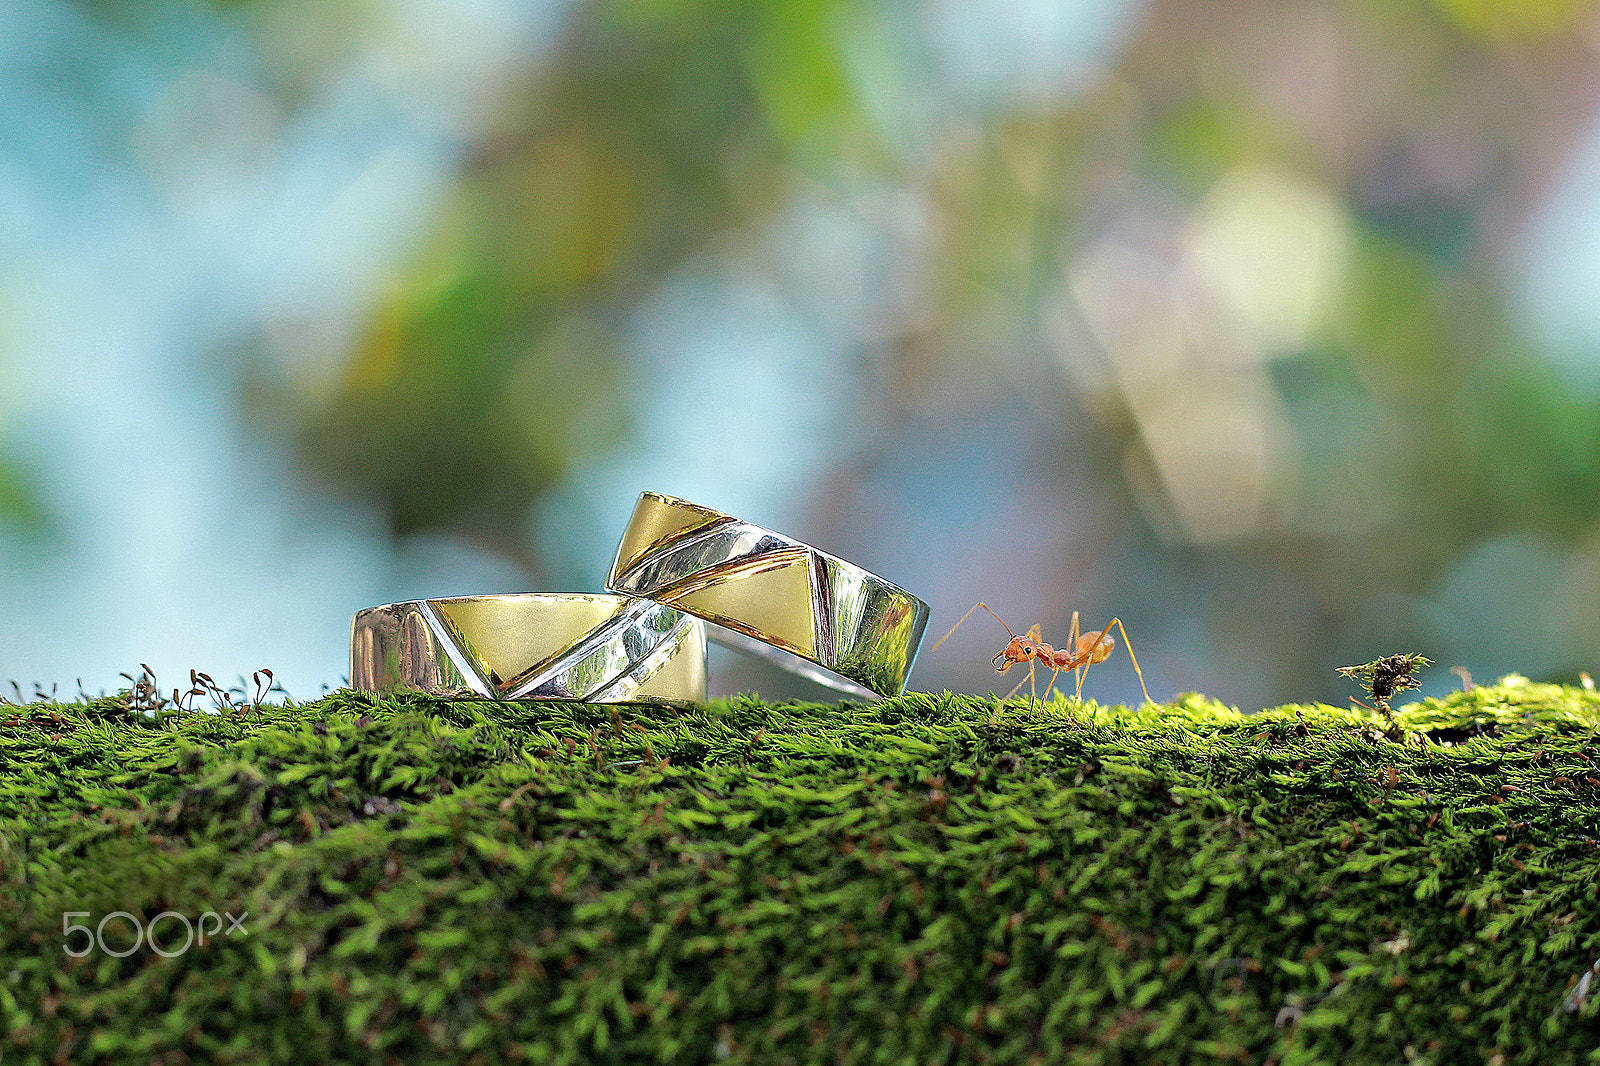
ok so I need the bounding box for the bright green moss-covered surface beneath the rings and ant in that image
[0,682,1600,1066]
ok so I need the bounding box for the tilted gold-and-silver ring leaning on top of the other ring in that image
[606,493,928,699]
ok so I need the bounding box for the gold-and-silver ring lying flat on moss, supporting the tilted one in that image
[350,592,706,706]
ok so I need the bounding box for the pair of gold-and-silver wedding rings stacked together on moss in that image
[350,493,928,704]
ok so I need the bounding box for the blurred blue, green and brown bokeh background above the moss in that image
[0,0,1600,709]
